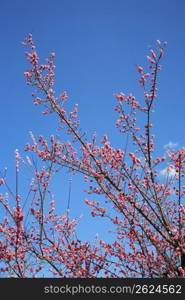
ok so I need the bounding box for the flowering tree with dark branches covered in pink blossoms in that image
[0,34,185,278]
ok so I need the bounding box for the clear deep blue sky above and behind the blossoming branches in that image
[0,0,185,238]
